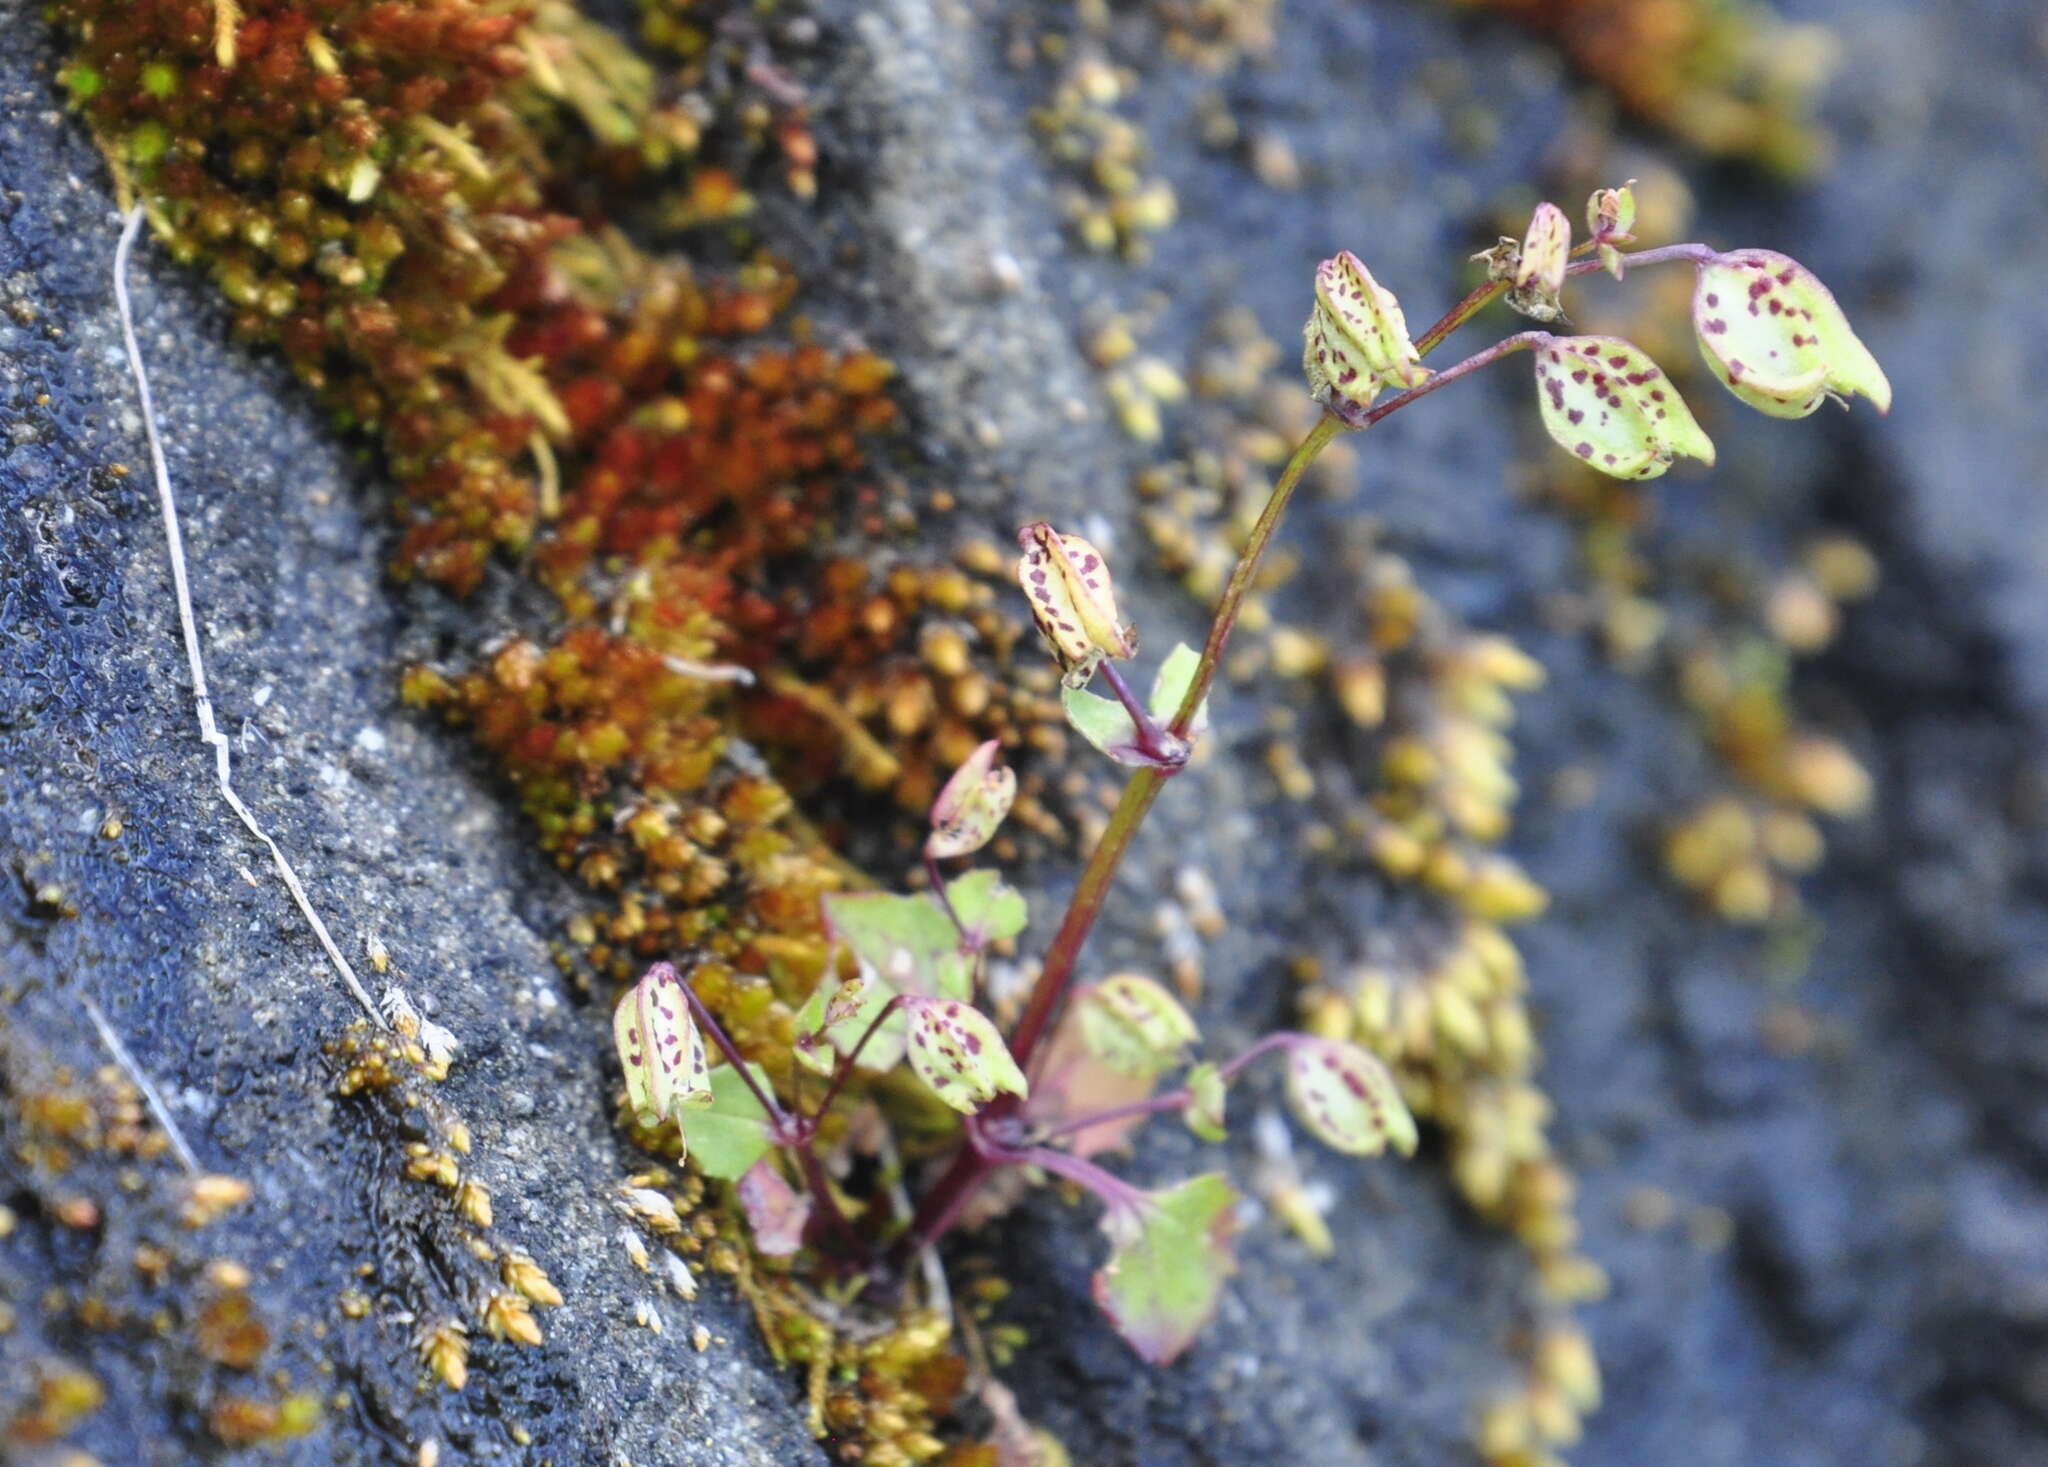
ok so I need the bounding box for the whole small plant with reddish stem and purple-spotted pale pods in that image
[614,188,1890,1363]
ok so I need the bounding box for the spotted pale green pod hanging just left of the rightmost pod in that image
[1536,336,1714,479]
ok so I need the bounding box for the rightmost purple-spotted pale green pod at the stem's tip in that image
[1692,250,1892,418]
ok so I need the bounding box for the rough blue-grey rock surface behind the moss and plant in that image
[0,0,2048,1467]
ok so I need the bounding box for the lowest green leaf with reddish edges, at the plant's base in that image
[1094,1172,1237,1365]
